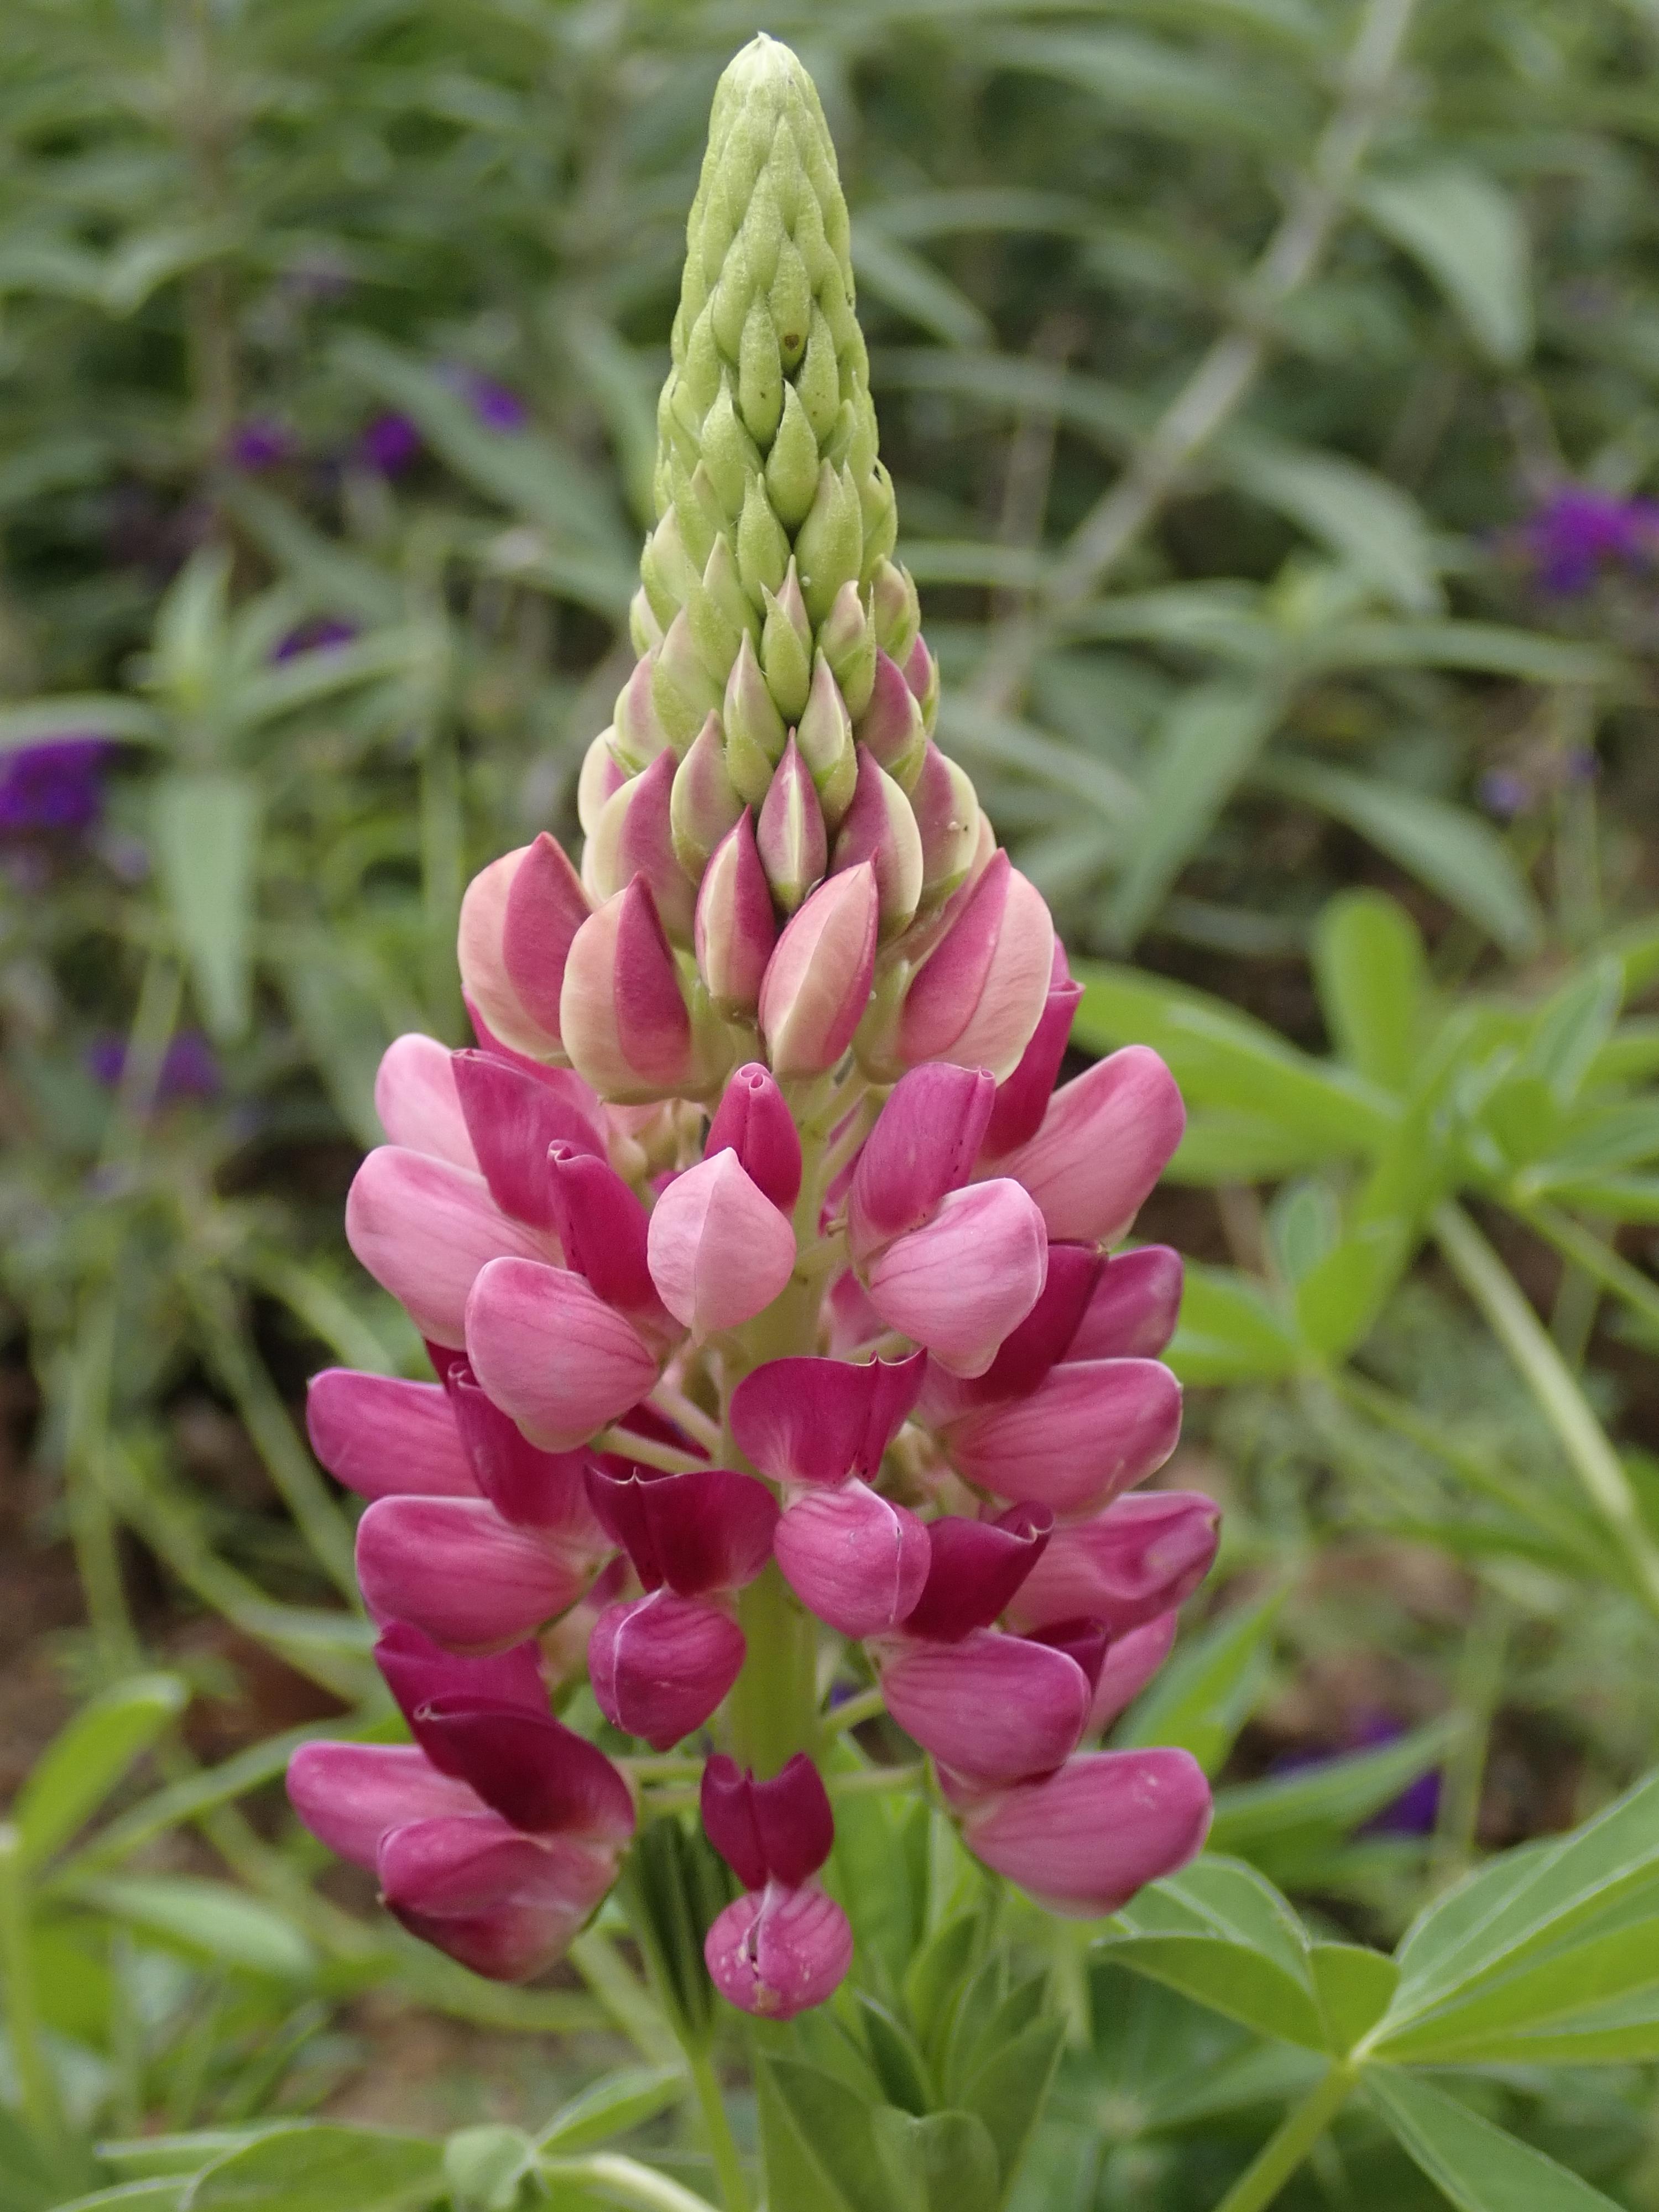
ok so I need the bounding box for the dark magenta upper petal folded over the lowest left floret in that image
[416,1690,635,1843]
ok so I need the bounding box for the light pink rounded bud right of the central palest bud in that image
[865,1179,1048,1376]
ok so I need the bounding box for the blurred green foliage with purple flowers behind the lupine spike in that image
[13,0,1659,2212]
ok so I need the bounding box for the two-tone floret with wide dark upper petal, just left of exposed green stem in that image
[588,1467,779,1752]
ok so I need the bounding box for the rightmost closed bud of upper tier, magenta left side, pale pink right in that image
[898,852,1053,1084]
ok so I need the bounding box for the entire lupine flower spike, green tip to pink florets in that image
[290,38,1217,2020]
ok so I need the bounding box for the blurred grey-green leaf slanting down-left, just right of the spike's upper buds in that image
[1106,679,1281,947]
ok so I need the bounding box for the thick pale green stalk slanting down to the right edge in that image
[1431,1201,1659,1613]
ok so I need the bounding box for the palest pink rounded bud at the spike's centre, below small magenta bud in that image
[648,1152,794,1343]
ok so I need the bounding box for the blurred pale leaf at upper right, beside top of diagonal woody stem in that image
[1356,166,1533,369]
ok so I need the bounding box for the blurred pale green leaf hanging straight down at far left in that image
[150,770,259,1040]
